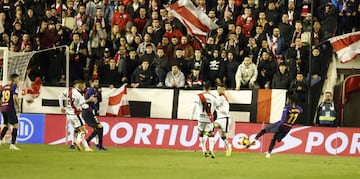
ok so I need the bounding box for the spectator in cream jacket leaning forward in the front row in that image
[235,57,258,90]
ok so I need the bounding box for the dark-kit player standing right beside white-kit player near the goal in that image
[82,79,107,150]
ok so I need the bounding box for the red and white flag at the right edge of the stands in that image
[329,31,360,63]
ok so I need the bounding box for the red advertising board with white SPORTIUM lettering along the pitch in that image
[45,115,360,156]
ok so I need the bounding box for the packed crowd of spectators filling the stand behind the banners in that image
[0,0,360,93]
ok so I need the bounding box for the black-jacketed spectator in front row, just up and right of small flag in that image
[131,59,153,88]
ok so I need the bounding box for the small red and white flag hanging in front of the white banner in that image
[106,84,130,117]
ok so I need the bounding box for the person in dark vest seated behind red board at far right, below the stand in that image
[318,91,337,127]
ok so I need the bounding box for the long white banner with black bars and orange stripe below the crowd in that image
[23,86,286,123]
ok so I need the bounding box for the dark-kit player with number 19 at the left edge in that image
[0,74,21,150]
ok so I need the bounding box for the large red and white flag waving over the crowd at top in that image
[166,0,218,44]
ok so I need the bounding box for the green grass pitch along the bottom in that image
[0,144,360,179]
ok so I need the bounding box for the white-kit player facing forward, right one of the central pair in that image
[214,84,232,157]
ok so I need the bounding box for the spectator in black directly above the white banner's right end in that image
[271,62,291,90]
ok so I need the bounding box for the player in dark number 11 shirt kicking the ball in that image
[249,95,303,158]
